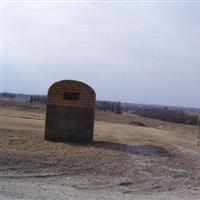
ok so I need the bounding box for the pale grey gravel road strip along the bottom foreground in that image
[0,176,200,200]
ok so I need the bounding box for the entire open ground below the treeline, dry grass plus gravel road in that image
[0,101,200,200]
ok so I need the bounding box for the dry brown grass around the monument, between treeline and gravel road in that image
[0,100,200,192]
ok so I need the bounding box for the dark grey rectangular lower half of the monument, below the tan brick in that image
[45,105,94,143]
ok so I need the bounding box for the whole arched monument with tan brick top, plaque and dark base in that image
[45,80,96,142]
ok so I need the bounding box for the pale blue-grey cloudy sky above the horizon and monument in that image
[2,1,200,108]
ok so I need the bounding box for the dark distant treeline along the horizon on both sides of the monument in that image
[0,92,199,125]
